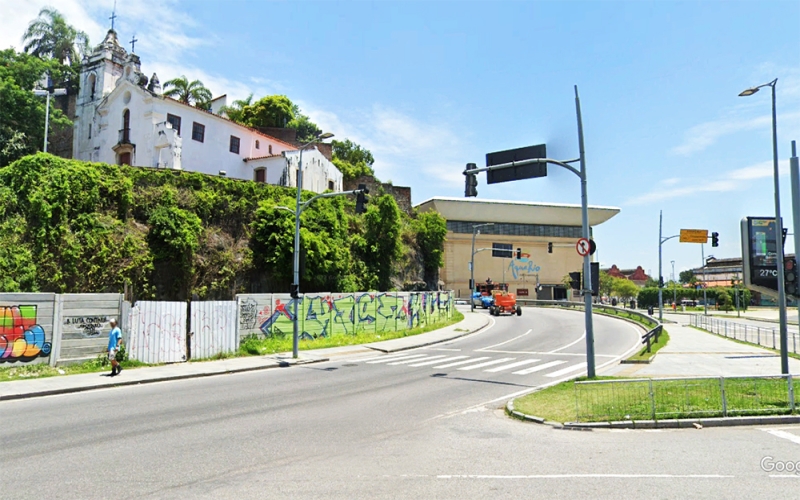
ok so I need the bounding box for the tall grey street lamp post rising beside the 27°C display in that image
[739,78,789,374]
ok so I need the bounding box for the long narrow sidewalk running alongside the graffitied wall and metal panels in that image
[0,310,489,401]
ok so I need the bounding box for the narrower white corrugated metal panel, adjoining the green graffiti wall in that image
[189,301,239,359]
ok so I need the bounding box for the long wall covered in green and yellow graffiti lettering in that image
[237,292,453,339]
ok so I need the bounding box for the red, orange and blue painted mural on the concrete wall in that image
[0,305,52,363]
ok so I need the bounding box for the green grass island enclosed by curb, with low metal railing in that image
[514,377,800,422]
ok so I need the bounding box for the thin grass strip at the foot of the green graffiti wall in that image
[238,309,464,356]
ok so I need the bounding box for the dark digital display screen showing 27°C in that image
[747,217,778,290]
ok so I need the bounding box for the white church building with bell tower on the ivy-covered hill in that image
[73,30,342,193]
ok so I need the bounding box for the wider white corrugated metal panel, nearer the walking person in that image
[127,301,187,363]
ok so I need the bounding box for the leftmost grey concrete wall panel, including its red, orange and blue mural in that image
[0,293,55,366]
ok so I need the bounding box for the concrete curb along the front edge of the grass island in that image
[506,400,800,431]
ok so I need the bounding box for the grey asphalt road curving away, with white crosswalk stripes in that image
[0,308,800,499]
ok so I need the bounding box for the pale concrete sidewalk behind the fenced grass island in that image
[601,324,800,378]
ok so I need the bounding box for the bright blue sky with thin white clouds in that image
[0,0,800,280]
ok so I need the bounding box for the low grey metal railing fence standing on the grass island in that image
[574,375,800,422]
